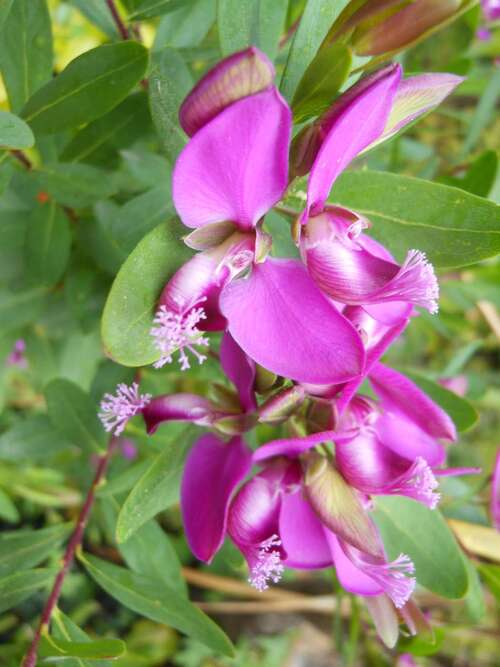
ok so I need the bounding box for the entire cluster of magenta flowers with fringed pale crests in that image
[101,48,476,648]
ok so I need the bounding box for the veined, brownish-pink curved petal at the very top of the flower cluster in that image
[179,46,274,137]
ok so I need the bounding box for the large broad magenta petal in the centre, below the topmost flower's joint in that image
[219,258,364,384]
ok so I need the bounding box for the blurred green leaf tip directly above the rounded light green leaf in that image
[110,187,175,255]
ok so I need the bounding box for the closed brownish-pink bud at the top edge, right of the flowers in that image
[351,0,462,56]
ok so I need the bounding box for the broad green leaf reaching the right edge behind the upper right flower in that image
[320,171,500,268]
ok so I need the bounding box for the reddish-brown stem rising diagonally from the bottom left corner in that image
[21,436,116,667]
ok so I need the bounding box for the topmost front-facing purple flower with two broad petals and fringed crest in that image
[152,49,364,383]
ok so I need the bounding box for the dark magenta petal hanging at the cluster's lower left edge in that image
[181,434,251,563]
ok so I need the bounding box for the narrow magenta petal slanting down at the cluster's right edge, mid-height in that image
[369,363,457,440]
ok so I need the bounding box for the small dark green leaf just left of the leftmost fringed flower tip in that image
[44,379,106,452]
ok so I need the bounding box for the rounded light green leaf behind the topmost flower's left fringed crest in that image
[102,220,191,366]
